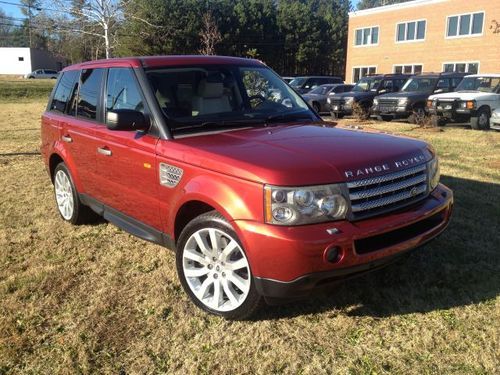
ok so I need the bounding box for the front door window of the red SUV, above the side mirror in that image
[106,68,144,117]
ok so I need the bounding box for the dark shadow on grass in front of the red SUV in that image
[255,176,500,320]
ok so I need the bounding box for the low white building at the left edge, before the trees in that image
[0,47,64,75]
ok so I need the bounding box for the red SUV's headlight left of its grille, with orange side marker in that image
[264,184,348,225]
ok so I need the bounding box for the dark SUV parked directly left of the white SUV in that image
[372,73,465,123]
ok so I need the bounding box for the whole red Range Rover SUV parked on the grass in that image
[41,56,453,319]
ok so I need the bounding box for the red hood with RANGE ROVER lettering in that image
[158,125,432,186]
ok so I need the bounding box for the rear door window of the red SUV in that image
[77,69,103,120]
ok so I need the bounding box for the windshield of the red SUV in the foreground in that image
[146,65,316,132]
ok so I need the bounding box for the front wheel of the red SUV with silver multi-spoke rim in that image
[176,211,263,320]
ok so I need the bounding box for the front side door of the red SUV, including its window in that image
[95,68,162,229]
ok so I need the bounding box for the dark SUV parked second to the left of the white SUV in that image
[330,74,410,118]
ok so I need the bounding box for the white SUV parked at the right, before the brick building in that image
[428,74,500,130]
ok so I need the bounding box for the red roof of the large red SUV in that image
[64,55,264,71]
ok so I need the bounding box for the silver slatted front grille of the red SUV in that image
[347,164,428,220]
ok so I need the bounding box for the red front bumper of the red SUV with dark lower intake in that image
[234,184,453,298]
